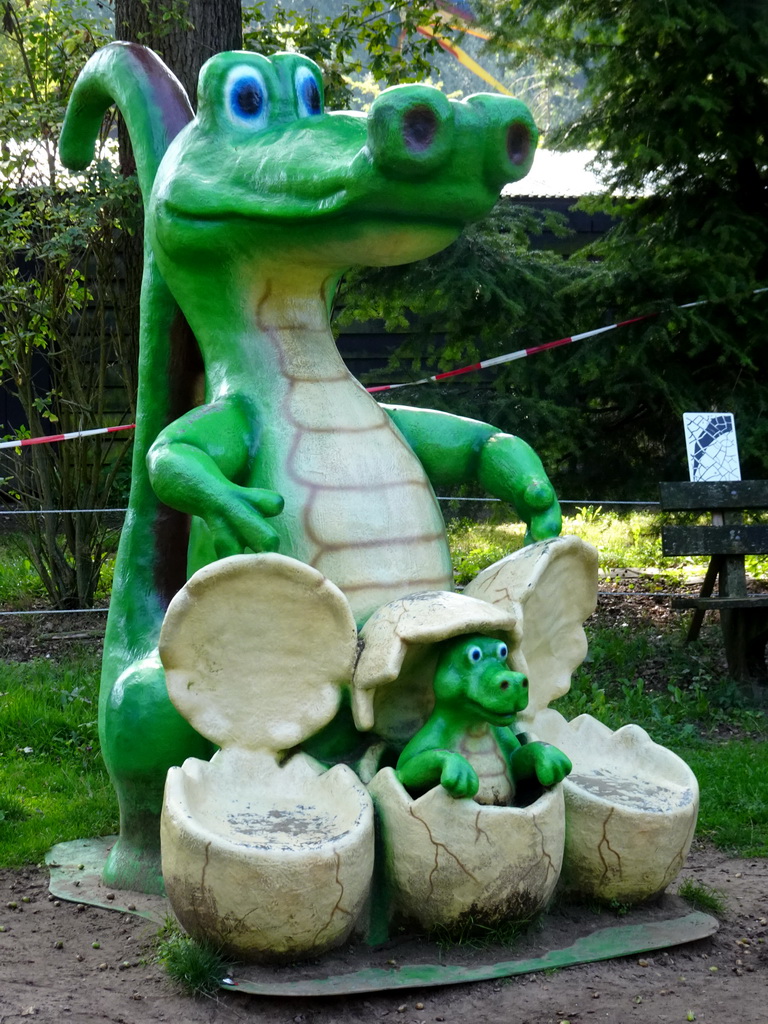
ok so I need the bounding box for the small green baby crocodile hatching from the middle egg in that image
[396,636,572,806]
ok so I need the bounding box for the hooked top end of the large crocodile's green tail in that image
[58,43,194,195]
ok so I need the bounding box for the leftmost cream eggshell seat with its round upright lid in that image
[160,554,374,959]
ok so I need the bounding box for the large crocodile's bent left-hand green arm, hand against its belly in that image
[147,394,283,558]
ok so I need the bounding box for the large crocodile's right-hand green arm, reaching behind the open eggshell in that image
[382,406,562,544]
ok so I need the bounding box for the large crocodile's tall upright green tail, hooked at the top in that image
[59,42,200,671]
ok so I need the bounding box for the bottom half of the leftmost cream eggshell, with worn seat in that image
[161,753,374,961]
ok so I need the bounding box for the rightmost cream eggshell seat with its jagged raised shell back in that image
[465,537,698,902]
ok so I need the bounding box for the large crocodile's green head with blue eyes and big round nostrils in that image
[150,52,537,270]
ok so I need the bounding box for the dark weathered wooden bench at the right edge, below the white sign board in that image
[659,480,768,682]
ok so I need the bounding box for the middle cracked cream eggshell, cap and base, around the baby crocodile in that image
[353,592,565,929]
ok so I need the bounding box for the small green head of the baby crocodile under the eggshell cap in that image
[433,635,528,725]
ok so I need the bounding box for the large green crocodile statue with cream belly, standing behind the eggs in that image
[59,43,560,891]
